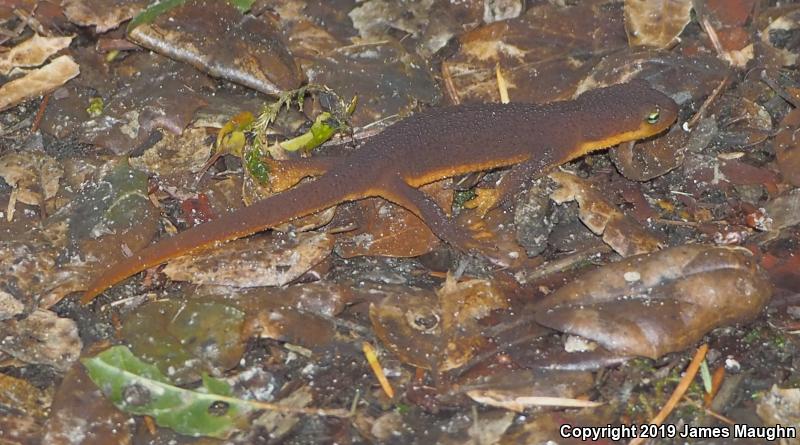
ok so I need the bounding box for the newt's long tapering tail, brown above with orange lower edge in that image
[81,175,356,303]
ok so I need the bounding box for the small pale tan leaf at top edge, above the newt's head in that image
[625,0,692,49]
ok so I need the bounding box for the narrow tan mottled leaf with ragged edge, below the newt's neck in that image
[550,172,661,256]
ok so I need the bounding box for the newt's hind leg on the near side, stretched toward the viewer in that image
[378,178,479,253]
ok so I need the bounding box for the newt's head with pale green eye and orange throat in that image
[576,80,678,153]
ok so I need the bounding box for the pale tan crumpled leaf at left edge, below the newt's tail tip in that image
[0,309,83,371]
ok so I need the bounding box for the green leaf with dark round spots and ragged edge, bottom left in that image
[81,346,251,438]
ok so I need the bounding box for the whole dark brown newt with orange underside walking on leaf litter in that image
[82,81,678,302]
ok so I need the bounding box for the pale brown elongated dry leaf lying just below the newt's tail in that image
[164,233,333,287]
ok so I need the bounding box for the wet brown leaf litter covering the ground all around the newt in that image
[0,0,800,443]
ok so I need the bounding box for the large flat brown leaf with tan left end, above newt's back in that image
[444,0,627,103]
